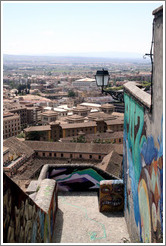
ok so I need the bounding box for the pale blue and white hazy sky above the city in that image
[1,1,165,55]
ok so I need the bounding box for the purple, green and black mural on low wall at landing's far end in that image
[47,166,111,191]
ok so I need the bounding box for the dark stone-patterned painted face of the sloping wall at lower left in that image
[3,174,57,243]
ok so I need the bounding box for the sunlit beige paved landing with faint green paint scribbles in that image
[54,192,129,243]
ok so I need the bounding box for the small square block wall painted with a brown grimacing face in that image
[99,180,124,212]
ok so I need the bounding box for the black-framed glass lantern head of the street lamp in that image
[95,69,110,93]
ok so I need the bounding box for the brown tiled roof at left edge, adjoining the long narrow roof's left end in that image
[3,137,34,158]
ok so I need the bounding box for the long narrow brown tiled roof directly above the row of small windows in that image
[24,141,114,154]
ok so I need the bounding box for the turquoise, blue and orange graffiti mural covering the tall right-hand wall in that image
[123,93,163,243]
